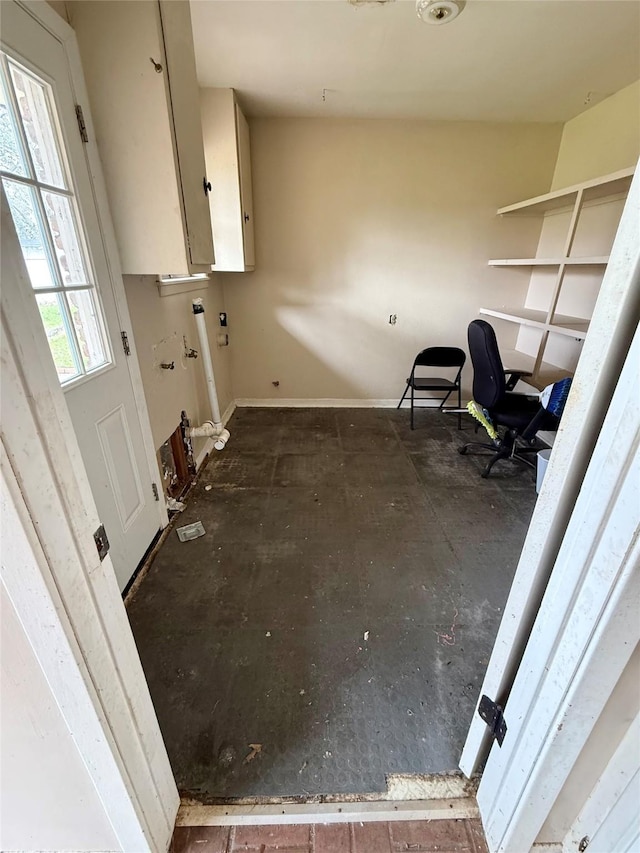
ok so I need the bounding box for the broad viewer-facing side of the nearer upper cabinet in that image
[72,0,187,275]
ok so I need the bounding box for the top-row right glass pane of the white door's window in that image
[9,63,66,189]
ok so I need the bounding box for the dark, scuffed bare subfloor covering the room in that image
[128,409,535,802]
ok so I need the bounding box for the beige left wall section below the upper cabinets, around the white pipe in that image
[124,275,232,454]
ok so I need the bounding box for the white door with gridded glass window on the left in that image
[0,2,161,589]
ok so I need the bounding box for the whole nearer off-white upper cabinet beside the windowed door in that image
[71,0,214,275]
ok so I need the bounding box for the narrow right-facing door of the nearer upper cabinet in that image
[159,0,214,267]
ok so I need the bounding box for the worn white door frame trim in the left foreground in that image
[0,155,179,853]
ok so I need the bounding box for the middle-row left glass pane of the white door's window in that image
[2,179,58,288]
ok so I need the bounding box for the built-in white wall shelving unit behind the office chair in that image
[479,168,634,388]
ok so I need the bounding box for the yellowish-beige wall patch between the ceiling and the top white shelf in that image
[551,80,640,189]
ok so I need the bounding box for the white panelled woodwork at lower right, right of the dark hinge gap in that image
[478,328,640,851]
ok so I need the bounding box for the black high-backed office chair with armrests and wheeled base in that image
[460,320,558,477]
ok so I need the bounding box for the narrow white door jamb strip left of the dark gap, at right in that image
[460,161,640,776]
